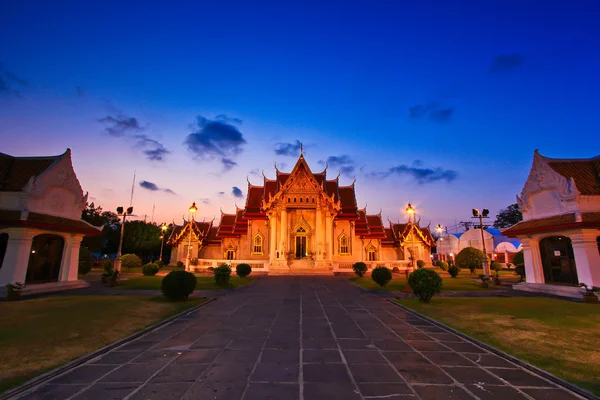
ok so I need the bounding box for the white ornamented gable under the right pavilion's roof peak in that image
[516,149,581,213]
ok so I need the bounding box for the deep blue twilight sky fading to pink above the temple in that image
[0,1,600,230]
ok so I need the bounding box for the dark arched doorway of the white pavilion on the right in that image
[540,236,579,285]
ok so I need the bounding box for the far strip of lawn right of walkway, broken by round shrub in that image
[350,269,510,292]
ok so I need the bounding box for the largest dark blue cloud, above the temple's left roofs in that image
[184,115,246,171]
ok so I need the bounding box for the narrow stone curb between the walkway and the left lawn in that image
[0,298,216,400]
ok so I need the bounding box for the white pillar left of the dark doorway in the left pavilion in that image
[0,229,35,286]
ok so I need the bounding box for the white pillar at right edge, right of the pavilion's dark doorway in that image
[569,230,600,286]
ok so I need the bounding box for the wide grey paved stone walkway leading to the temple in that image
[17,277,578,400]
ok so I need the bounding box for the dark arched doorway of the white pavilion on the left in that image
[25,234,65,283]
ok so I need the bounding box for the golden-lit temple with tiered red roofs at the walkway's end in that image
[169,155,435,273]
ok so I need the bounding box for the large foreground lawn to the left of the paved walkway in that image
[0,296,205,393]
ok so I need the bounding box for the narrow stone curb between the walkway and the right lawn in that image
[386,299,600,400]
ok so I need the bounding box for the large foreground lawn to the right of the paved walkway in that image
[397,297,600,395]
